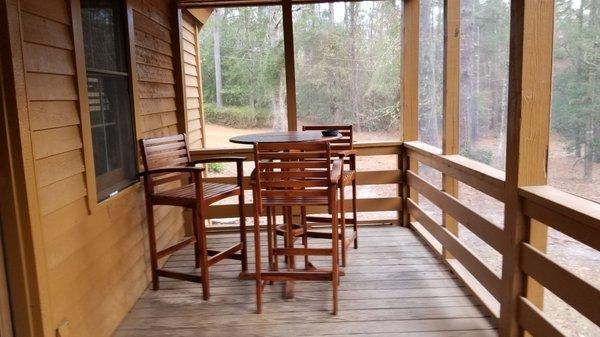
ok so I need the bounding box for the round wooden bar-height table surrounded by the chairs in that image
[229,131,343,299]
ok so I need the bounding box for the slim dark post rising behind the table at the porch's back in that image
[282,0,298,131]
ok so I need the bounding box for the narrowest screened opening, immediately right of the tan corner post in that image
[419,0,444,148]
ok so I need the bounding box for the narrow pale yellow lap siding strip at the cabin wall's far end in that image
[181,12,204,148]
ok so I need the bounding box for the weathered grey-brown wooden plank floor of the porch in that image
[114,227,497,337]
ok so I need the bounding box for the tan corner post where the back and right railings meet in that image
[402,0,419,226]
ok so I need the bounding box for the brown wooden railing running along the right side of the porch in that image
[403,142,600,337]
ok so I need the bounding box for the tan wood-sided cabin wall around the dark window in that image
[14,0,184,337]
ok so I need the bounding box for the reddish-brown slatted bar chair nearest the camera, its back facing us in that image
[253,142,343,314]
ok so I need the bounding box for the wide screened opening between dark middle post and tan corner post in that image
[292,0,402,141]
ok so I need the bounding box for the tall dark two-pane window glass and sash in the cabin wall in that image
[81,0,137,200]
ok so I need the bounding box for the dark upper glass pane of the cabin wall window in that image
[81,0,127,72]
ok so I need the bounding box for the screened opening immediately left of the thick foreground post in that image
[459,0,510,170]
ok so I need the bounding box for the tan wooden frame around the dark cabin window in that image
[70,0,141,210]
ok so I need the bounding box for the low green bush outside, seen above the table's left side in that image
[204,103,270,129]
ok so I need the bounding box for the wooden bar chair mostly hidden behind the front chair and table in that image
[302,125,358,267]
